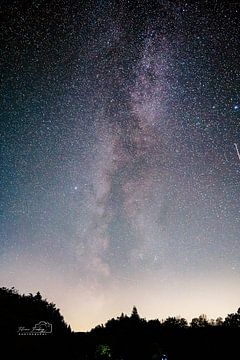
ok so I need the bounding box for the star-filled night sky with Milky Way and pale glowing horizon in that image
[0,0,240,331]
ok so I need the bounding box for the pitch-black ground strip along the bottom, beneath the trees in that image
[1,328,240,360]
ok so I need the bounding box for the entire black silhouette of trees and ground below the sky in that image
[0,288,240,360]
